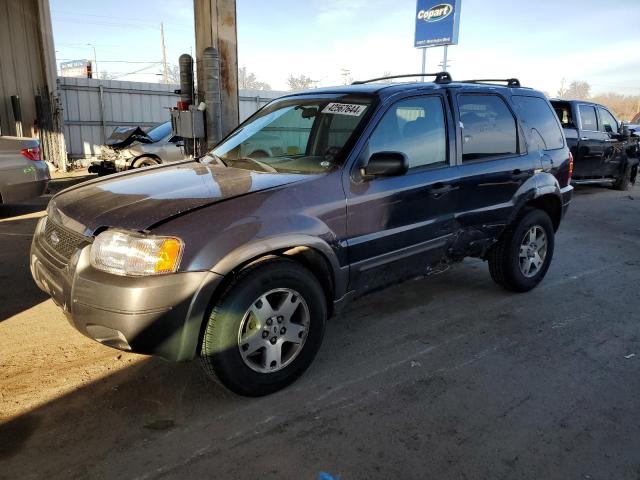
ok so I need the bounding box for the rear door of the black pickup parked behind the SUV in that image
[573,104,606,179]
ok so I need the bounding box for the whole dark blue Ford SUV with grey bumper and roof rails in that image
[31,72,572,396]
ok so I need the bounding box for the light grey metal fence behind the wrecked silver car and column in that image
[59,77,284,159]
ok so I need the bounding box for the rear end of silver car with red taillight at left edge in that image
[0,136,50,203]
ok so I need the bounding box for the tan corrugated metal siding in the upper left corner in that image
[0,0,45,136]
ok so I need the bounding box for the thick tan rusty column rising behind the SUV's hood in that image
[193,0,239,136]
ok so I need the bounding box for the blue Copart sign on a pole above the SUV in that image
[415,0,461,48]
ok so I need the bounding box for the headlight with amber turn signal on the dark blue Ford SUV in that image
[91,230,183,277]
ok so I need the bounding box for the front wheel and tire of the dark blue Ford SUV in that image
[200,258,327,397]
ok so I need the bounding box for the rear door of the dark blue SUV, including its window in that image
[455,89,542,234]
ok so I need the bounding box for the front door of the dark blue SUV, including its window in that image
[345,94,459,293]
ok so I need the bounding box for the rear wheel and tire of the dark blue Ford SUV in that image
[488,209,555,292]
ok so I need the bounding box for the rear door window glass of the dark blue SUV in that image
[458,94,518,161]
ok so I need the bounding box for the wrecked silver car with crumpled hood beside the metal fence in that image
[89,122,189,175]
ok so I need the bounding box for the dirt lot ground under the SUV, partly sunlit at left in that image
[0,181,640,480]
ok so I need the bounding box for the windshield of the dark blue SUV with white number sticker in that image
[208,96,371,174]
